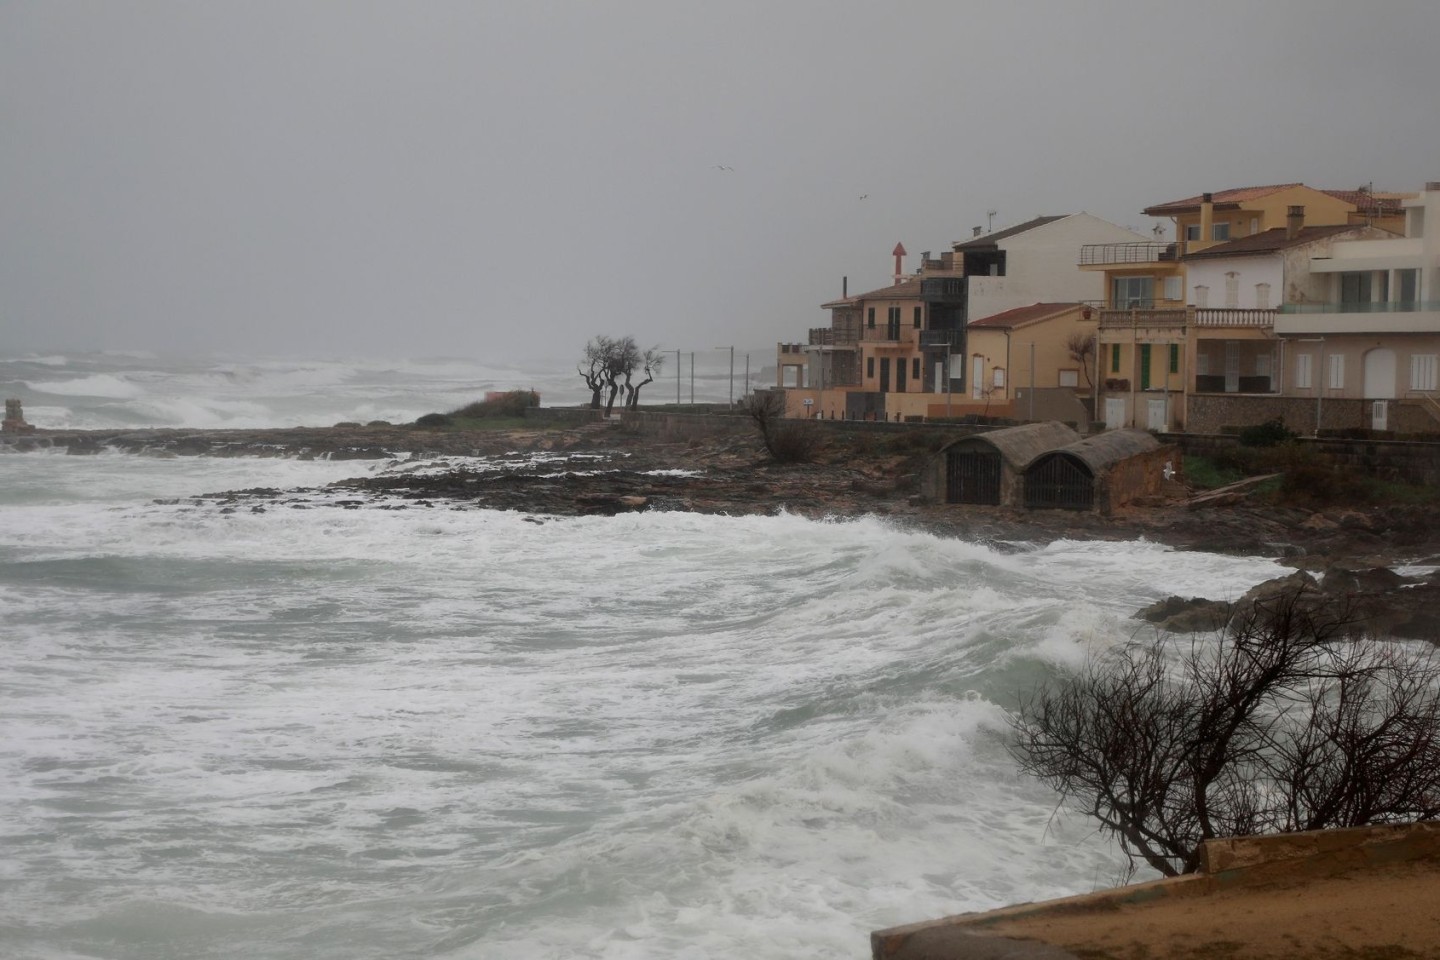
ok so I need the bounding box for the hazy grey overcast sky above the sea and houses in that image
[0,0,1440,360]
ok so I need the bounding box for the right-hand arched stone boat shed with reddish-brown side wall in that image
[1024,430,1176,514]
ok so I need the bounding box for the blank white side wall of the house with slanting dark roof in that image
[969,213,1153,320]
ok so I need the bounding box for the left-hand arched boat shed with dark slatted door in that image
[920,420,1080,507]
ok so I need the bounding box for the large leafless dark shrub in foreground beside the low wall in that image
[1012,592,1440,877]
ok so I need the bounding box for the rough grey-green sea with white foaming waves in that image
[0,354,1283,960]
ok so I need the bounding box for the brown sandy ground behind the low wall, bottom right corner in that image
[985,861,1440,960]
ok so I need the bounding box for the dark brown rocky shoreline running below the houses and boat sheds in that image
[10,422,1440,642]
